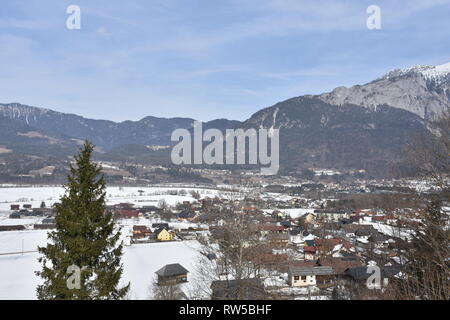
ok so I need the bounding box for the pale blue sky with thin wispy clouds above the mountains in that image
[0,0,450,121]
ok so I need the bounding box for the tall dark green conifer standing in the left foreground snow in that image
[36,141,129,300]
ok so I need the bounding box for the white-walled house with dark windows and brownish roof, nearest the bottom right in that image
[288,266,333,287]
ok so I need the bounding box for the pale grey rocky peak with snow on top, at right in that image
[318,63,450,120]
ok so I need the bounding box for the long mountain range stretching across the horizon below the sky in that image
[0,63,450,178]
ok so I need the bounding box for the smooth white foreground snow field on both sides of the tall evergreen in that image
[0,230,204,300]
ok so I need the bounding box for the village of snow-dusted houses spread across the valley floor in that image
[0,179,442,300]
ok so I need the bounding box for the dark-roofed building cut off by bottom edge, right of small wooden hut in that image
[211,278,267,300]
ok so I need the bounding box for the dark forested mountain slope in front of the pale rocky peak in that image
[243,97,428,175]
